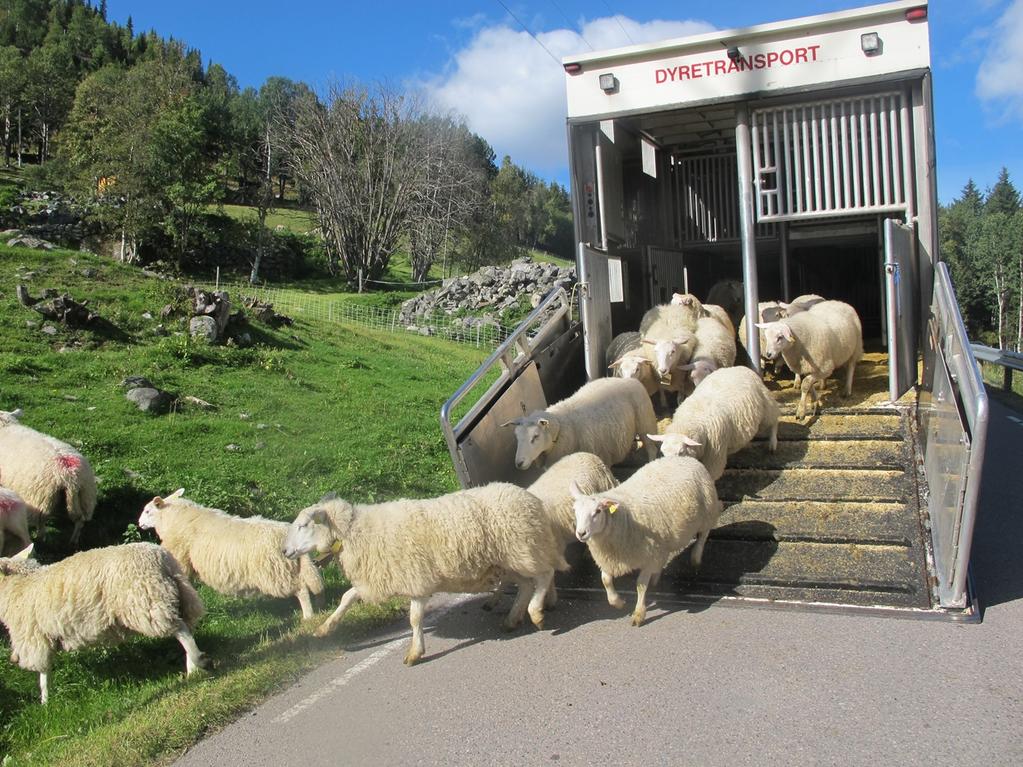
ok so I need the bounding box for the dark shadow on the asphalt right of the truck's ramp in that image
[970,387,1023,610]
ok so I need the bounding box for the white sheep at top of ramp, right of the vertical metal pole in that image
[758,301,863,419]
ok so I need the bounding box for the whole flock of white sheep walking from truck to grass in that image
[0,286,862,703]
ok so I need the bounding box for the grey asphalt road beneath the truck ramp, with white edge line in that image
[177,402,1023,767]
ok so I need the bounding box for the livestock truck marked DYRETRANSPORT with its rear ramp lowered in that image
[441,2,987,620]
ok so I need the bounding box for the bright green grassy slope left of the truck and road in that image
[0,246,485,765]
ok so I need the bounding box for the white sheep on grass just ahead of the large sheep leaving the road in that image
[138,488,323,619]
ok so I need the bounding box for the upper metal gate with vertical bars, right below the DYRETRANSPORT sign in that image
[751,92,909,221]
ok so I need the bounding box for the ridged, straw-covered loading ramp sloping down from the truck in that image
[560,354,933,611]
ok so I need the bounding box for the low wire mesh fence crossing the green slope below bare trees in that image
[205,282,515,349]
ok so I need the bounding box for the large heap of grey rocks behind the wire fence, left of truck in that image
[399,258,576,334]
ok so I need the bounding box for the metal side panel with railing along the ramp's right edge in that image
[919,262,988,608]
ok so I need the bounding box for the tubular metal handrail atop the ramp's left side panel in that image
[440,287,572,486]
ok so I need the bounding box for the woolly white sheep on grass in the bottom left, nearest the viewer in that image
[0,543,206,704]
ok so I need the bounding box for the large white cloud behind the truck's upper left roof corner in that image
[427,16,714,177]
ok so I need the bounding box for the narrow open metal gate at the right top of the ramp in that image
[884,219,920,402]
